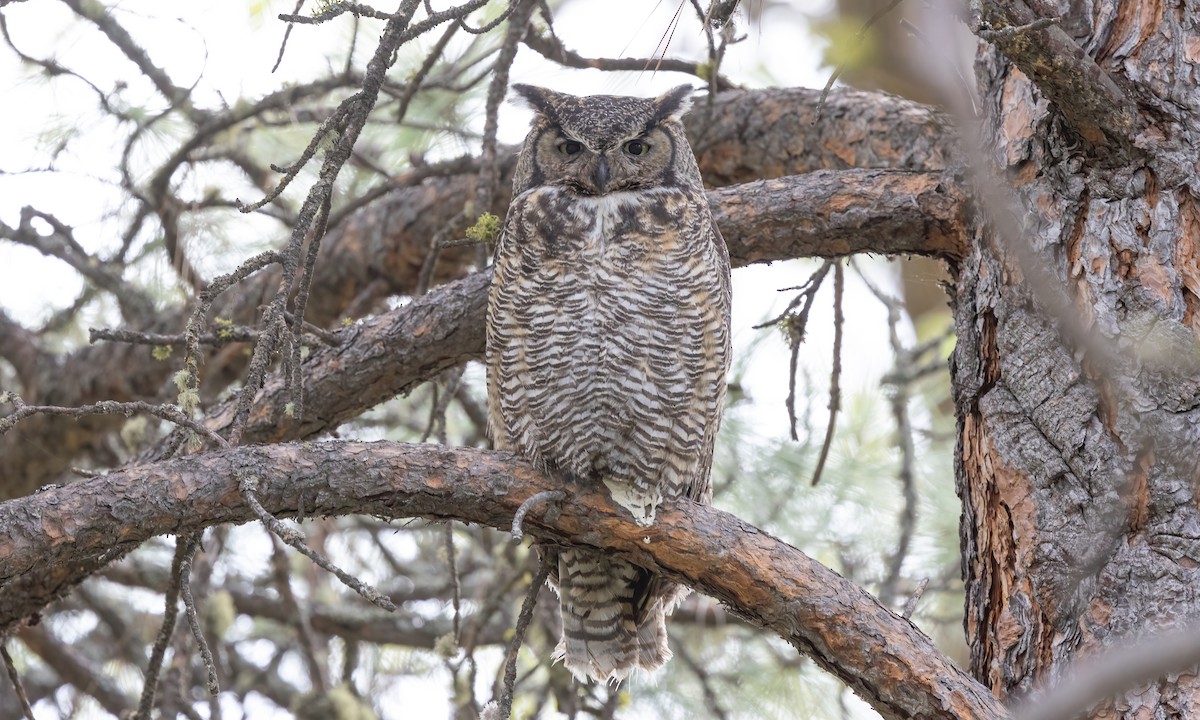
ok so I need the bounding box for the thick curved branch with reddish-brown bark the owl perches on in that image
[0,442,1007,719]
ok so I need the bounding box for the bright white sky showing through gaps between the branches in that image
[0,0,916,720]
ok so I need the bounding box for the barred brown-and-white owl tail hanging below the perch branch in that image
[553,550,671,684]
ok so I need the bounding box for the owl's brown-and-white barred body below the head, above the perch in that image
[487,187,728,523]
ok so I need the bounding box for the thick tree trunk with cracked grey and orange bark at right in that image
[952,0,1200,718]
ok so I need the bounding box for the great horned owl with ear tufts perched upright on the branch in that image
[487,85,730,682]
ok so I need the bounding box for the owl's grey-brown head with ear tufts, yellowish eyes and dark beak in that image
[512,85,702,196]
